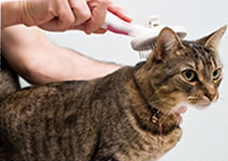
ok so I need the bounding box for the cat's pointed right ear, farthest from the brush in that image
[196,26,227,51]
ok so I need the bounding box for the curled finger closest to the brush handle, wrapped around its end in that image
[85,0,107,34]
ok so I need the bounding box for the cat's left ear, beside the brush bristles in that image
[154,27,182,59]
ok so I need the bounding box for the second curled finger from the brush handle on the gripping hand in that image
[69,0,91,25]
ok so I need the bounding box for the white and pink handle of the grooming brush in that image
[102,11,148,37]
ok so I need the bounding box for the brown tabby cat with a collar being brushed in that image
[1,26,226,161]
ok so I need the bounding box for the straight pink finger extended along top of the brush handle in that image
[108,1,132,22]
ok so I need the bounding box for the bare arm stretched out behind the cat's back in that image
[2,25,120,84]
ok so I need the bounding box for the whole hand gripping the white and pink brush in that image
[18,0,131,34]
